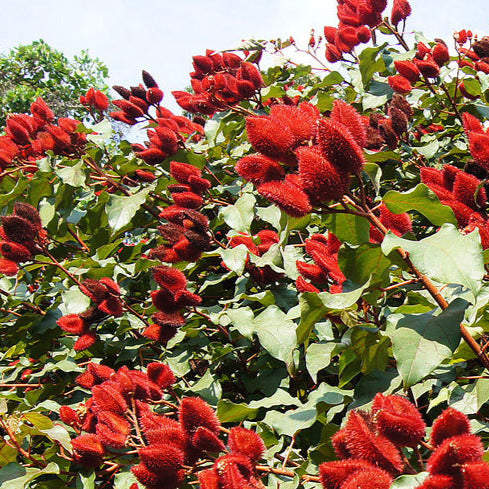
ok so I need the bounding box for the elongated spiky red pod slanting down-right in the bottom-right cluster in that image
[345,411,404,474]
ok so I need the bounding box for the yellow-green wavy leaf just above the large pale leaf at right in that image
[383,183,457,226]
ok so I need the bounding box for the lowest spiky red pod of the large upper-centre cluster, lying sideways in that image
[258,181,312,217]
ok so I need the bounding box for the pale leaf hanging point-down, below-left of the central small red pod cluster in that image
[255,306,297,364]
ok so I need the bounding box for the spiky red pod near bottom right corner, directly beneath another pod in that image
[428,435,484,475]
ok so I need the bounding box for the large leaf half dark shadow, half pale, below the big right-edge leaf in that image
[386,299,468,387]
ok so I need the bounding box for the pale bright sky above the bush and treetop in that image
[0,0,489,110]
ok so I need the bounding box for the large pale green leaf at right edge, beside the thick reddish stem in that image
[381,224,485,296]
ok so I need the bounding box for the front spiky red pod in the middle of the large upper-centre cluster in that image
[296,147,350,202]
